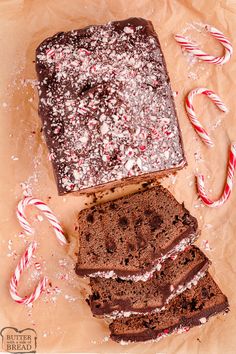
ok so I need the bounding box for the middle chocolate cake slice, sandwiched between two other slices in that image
[88,246,210,317]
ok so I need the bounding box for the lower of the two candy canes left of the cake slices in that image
[9,241,48,305]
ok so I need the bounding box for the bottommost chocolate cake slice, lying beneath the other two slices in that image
[110,273,229,342]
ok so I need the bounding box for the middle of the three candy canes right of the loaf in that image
[185,87,228,147]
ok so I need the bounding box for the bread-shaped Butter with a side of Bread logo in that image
[0,327,37,353]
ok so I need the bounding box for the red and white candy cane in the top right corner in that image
[174,25,233,65]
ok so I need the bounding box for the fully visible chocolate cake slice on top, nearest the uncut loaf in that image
[76,185,197,281]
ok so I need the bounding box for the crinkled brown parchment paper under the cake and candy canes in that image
[0,0,236,354]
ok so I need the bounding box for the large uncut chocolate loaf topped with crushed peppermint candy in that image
[36,18,186,194]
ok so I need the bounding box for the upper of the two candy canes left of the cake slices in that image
[16,197,67,245]
